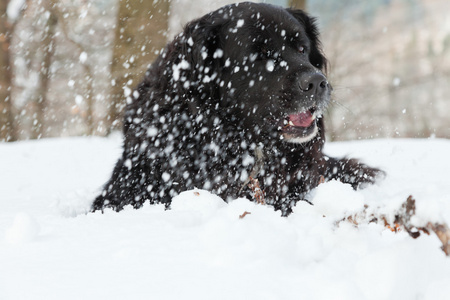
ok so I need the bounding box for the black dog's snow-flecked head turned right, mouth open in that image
[169,3,331,143]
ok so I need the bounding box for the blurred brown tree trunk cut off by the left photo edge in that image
[0,0,17,141]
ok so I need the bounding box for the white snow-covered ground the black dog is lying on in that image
[0,136,450,300]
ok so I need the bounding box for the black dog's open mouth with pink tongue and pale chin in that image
[279,107,320,143]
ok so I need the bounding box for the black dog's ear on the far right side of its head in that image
[286,9,328,73]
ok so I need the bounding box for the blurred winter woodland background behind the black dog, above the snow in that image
[0,0,450,141]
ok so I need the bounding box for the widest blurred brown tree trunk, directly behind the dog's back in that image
[105,0,170,130]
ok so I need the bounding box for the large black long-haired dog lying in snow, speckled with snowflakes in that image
[92,3,382,215]
